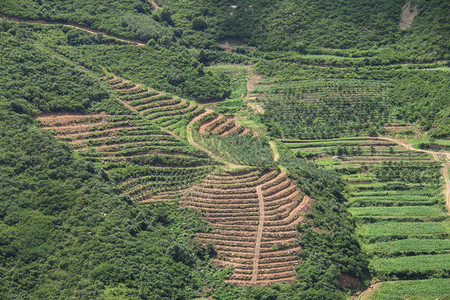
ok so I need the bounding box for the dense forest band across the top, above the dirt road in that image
[0,0,450,60]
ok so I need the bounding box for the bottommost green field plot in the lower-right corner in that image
[367,278,450,300]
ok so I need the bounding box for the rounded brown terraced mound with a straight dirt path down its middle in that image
[180,169,312,284]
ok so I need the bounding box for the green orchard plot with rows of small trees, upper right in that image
[257,60,450,139]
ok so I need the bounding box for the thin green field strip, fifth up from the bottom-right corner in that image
[349,206,442,217]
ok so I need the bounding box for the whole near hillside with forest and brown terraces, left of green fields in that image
[0,25,367,299]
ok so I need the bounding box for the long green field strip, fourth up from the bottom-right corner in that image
[358,222,450,237]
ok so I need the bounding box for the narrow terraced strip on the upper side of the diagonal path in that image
[106,76,250,137]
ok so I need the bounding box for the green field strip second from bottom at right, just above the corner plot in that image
[371,254,450,275]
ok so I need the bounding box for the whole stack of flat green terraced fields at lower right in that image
[284,138,450,299]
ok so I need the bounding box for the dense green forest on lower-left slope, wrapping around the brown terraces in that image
[0,37,216,299]
